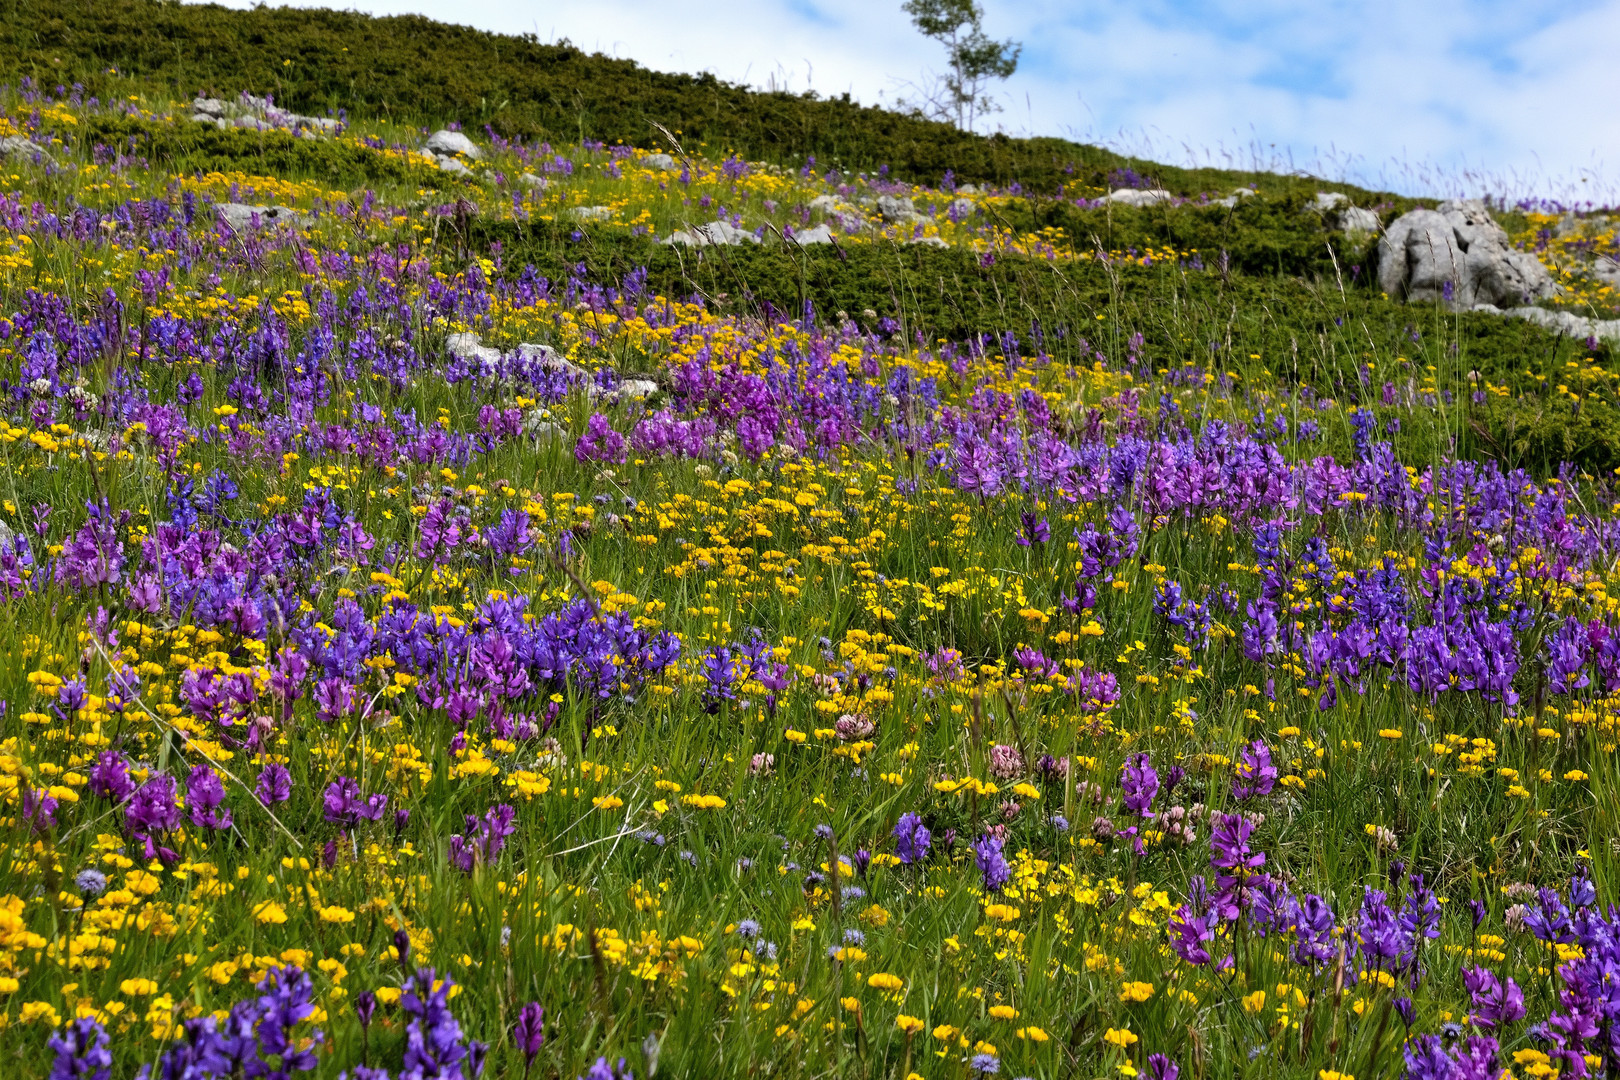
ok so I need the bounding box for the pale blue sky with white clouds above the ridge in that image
[202,0,1620,202]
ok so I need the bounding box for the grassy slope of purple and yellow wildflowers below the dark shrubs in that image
[0,82,1620,1080]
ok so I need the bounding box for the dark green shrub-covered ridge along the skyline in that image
[0,0,1393,201]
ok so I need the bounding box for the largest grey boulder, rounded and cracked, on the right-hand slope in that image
[1379,199,1558,311]
